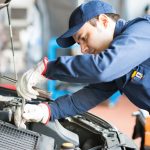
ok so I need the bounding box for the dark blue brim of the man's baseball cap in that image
[56,23,84,48]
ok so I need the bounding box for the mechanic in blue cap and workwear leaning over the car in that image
[16,0,150,126]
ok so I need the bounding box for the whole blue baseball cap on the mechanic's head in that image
[56,0,116,48]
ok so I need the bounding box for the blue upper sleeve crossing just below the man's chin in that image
[46,19,150,84]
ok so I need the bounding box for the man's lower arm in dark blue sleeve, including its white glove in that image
[14,82,118,127]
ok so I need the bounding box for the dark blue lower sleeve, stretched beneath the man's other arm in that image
[50,82,117,120]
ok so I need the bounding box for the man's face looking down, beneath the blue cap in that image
[73,15,113,54]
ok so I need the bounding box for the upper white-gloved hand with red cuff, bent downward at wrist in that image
[16,58,48,100]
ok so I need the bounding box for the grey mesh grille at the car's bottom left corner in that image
[0,121,40,150]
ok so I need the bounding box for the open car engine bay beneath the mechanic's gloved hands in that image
[0,87,137,150]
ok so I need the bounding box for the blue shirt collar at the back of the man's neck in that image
[114,19,126,38]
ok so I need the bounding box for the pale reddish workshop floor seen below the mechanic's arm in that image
[89,95,140,147]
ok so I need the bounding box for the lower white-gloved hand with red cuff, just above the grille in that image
[14,103,51,128]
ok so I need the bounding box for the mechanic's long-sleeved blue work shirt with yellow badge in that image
[46,15,150,120]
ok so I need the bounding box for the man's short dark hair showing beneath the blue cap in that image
[89,13,120,26]
